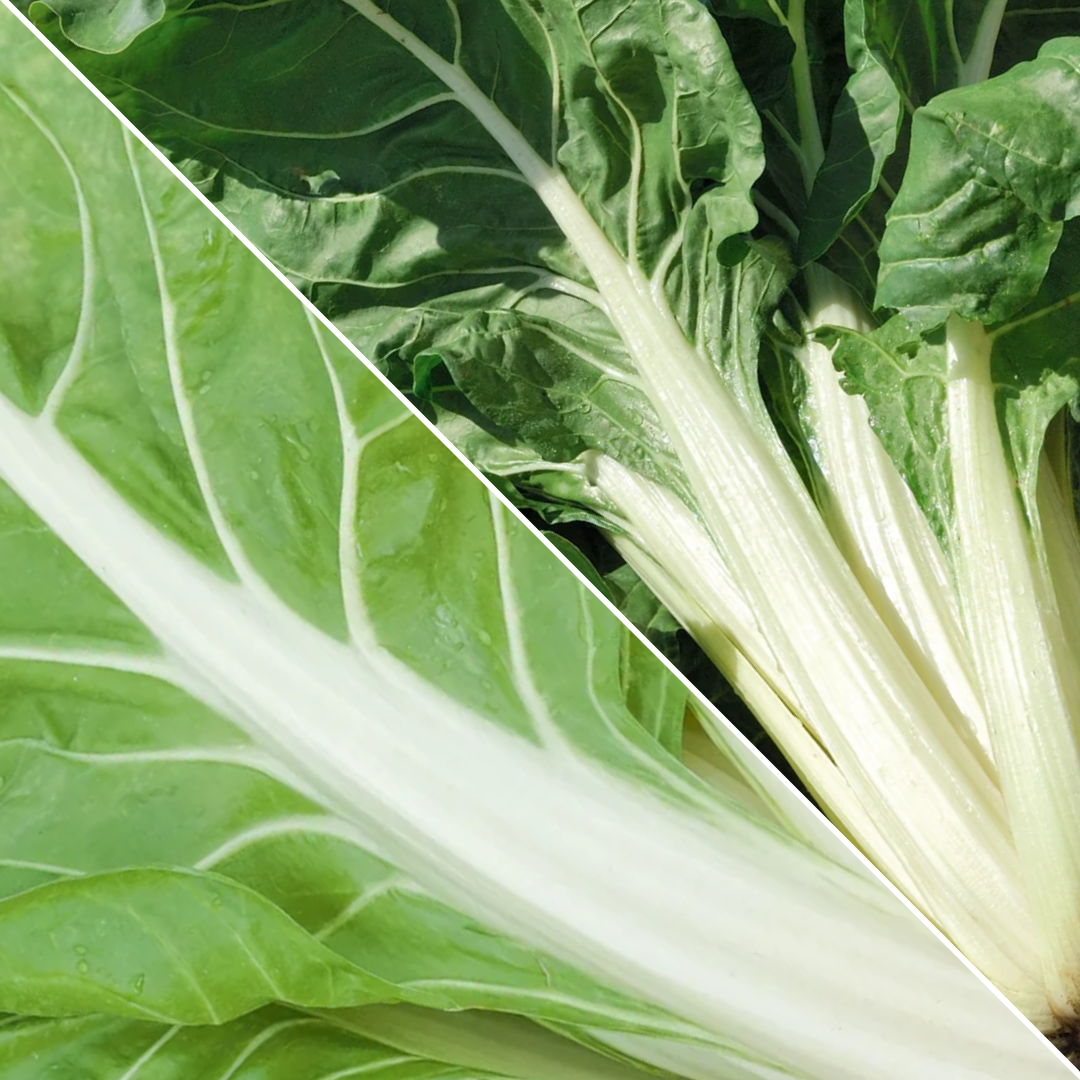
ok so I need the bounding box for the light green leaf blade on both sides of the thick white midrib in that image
[0,6,743,1071]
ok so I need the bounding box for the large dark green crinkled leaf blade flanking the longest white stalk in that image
[23,0,760,496]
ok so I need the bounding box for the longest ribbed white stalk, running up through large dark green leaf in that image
[347,0,1038,1019]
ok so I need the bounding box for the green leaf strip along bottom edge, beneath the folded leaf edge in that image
[0,1007,682,1080]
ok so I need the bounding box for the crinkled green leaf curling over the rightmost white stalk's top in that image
[877,38,1080,323]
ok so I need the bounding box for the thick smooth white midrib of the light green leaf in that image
[0,396,1059,1080]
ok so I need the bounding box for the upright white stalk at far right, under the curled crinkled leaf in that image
[946,314,1080,1020]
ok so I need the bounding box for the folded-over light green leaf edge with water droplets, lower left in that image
[0,869,408,1024]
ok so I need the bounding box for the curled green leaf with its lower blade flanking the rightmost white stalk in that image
[820,27,1080,565]
